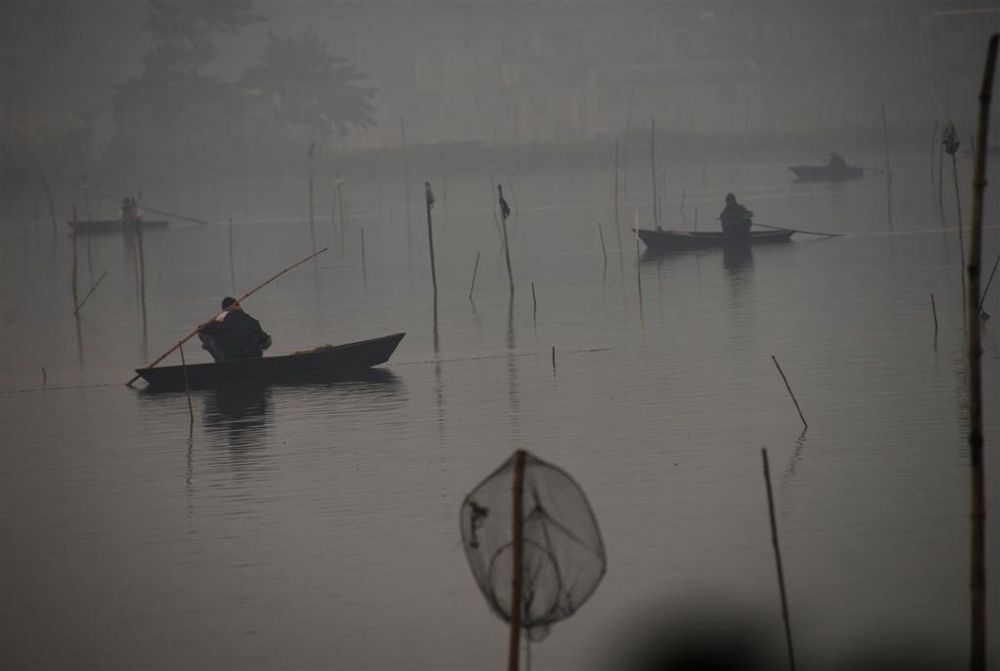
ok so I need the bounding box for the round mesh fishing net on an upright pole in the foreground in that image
[461,452,607,641]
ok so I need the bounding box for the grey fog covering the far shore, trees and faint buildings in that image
[0,2,1000,213]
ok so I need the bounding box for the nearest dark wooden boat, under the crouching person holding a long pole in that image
[135,333,405,390]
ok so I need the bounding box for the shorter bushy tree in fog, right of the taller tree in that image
[242,30,375,138]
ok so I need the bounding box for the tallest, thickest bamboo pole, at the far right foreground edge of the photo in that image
[965,34,1000,671]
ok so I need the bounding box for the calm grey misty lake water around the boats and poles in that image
[0,150,1000,670]
